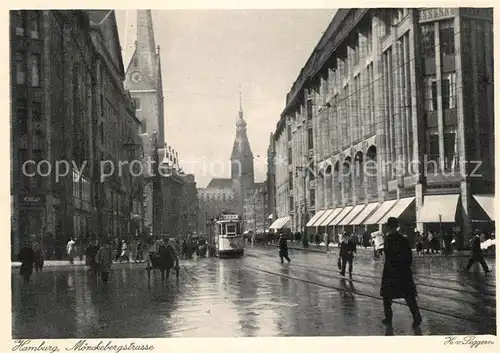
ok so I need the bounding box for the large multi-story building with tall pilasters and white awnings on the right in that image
[274,8,494,245]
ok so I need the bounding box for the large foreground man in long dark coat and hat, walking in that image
[380,217,422,328]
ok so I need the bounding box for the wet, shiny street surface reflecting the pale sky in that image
[12,243,496,338]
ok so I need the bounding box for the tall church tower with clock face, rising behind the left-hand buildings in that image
[124,10,165,235]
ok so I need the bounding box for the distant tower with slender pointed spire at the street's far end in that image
[231,93,254,220]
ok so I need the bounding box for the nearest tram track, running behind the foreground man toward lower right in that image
[244,264,490,323]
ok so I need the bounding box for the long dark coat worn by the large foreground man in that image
[380,232,417,299]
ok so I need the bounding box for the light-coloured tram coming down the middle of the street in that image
[209,212,245,257]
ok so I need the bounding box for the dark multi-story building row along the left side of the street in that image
[10,10,143,257]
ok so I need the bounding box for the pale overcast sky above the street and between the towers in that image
[117,9,336,187]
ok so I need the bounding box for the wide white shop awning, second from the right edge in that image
[417,194,460,223]
